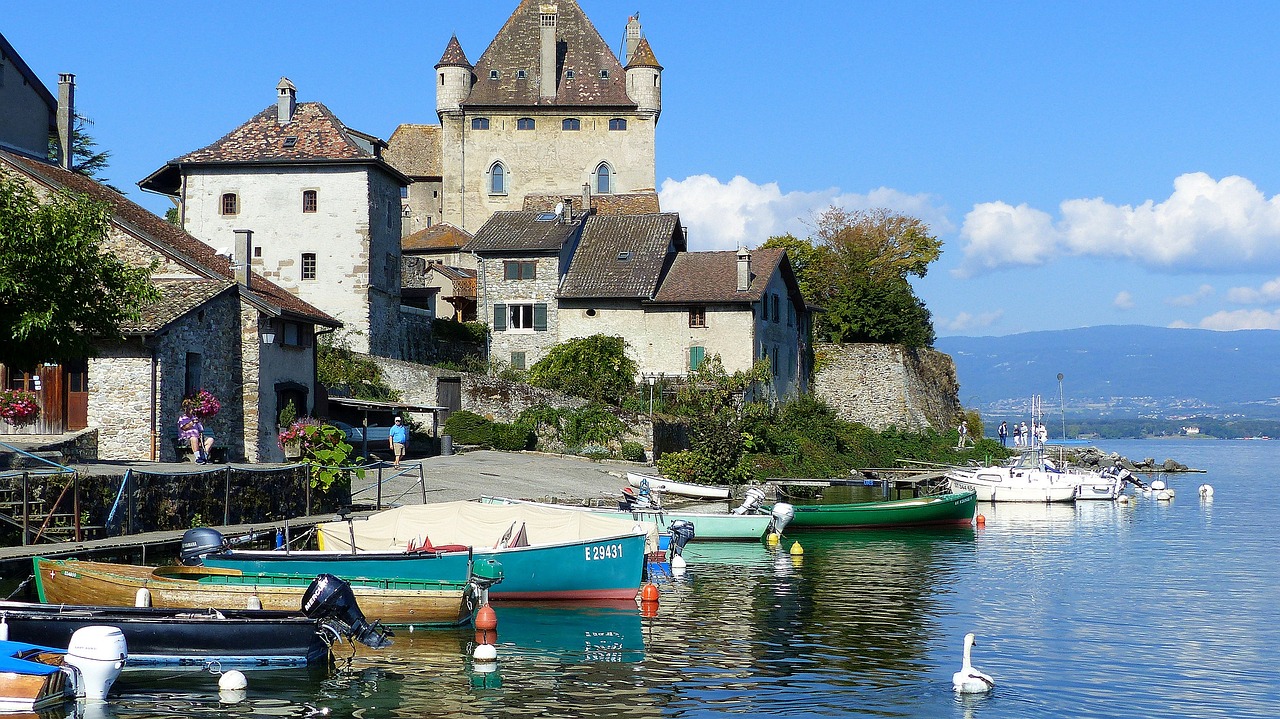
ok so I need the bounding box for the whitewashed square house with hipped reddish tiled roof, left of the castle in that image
[138,78,410,357]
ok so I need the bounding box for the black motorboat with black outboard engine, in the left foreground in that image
[0,568,390,669]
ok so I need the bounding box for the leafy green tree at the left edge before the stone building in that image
[0,171,160,370]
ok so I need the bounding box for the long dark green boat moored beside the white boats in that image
[787,491,978,531]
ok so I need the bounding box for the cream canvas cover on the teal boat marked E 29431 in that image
[316,502,658,551]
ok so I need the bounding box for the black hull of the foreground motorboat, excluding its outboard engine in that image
[0,601,330,669]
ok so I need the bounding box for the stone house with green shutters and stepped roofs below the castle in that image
[467,210,812,398]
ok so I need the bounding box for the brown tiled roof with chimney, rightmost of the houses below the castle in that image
[653,247,794,304]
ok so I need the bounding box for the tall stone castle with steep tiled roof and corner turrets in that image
[392,0,662,232]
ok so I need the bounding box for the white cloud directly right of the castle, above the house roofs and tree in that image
[658,174,955,249]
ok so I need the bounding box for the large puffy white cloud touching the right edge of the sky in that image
[955,173,1280,276]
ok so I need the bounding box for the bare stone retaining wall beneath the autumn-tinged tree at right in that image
[814,344,960,431]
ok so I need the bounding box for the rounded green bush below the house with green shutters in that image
[529,334,637,404]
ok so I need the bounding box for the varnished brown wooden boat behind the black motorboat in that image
[33,557,474,627]
